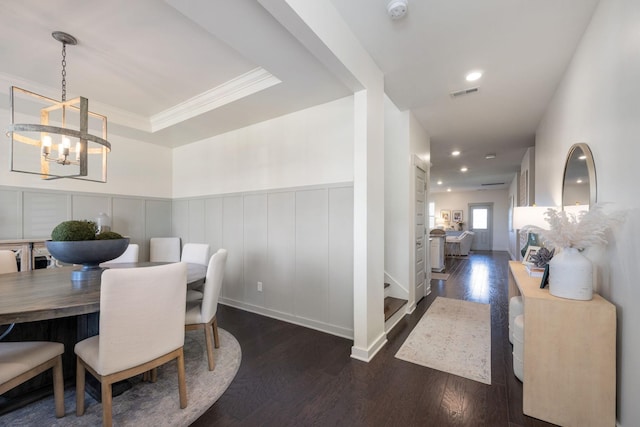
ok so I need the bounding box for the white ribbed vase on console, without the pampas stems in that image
[549,248,593,301]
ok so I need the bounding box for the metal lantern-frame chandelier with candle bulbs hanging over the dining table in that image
[7,31,111,182]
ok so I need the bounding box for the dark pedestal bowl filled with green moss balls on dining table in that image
[45,221,129,281]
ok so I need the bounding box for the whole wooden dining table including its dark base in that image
[0,262,207,414]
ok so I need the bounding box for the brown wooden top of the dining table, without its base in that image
[0,262,207,325]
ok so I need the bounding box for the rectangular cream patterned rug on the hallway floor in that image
[396,297,491,384]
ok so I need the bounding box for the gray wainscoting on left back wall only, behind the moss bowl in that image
[0,186,171,261]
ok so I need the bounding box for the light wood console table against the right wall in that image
[509,261,616,427]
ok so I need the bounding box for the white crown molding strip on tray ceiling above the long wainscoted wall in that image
[150,67,281,132]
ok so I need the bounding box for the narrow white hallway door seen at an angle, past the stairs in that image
[415,166,427,304]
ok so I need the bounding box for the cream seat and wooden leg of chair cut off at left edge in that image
[0,341,64,418]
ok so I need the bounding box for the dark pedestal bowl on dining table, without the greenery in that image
[45,238,129,280]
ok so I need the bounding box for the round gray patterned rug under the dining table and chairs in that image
[0,328,242,427]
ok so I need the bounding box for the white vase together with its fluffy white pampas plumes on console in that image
[524,205,623,301]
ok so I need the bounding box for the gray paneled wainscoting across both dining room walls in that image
[0,183,353,338]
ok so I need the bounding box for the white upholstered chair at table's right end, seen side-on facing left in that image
[185,249,227,371]
